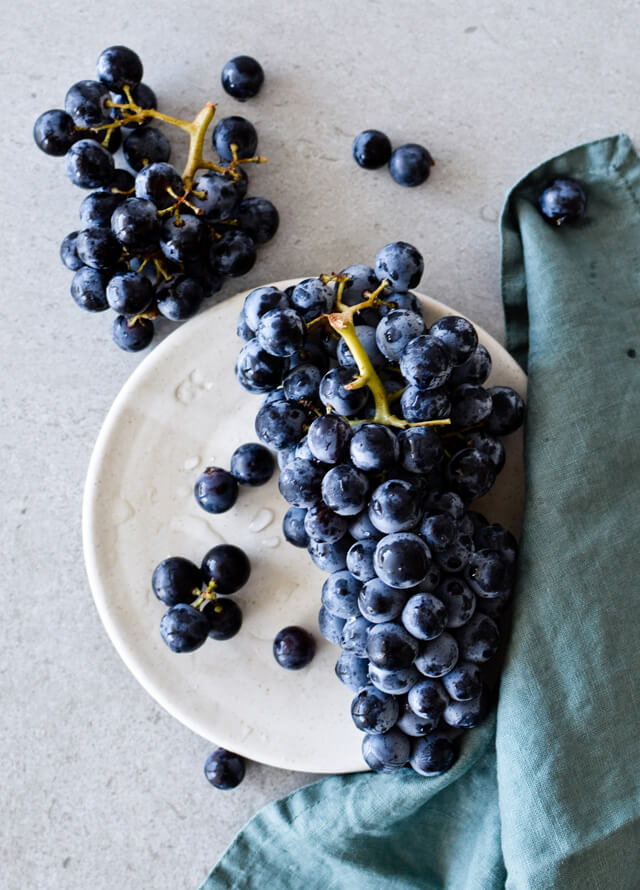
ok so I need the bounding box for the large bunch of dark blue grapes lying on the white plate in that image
[235,242,524,775]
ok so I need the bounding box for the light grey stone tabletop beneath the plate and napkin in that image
[5,0,640,890]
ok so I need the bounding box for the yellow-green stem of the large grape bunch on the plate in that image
[323,275,451,429]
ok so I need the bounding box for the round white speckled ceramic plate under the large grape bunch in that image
[83,279,526,773]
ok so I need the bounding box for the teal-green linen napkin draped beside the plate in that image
[201,135,640,890]
